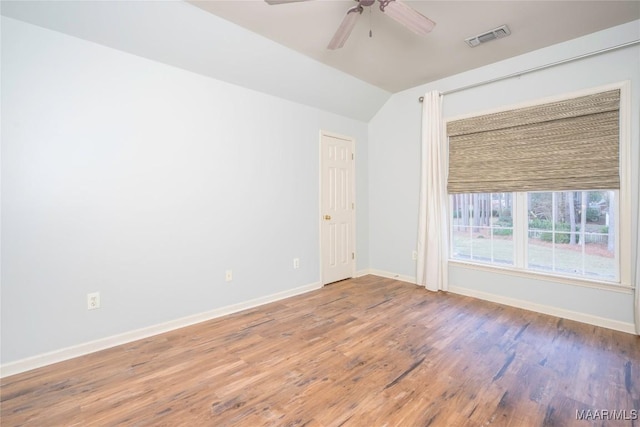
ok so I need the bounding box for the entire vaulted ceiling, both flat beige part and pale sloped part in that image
[0,0,640,121]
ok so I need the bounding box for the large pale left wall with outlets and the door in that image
[1,17,369,364]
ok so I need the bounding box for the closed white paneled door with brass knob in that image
[320,132,355,285]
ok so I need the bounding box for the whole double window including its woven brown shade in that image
[447,83,632,285]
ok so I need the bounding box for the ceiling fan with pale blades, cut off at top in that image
[264,0,436,50]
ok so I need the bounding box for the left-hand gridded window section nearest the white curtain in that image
[451,193,514,265]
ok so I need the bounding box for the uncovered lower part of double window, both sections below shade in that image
[450,190,620,282]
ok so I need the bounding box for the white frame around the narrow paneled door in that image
[318,129,358,287]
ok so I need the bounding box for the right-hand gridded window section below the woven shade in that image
[527,191,618,280]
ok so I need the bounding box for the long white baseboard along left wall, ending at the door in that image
[0,282,322,378]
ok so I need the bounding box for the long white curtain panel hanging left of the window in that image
[416,91,449,291]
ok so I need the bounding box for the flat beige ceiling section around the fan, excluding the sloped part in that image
[189,0,640,93]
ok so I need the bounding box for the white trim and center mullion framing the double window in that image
[445,80,640,291]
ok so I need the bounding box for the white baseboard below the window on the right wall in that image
[449,286,636,335]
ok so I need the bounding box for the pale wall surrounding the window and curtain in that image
[369,21,640,330]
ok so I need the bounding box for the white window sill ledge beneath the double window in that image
[449,259,634,294]
